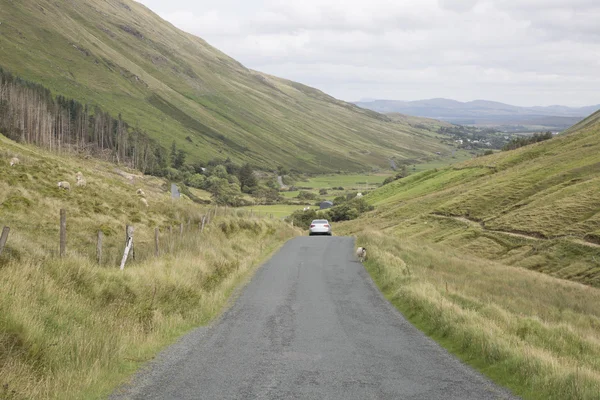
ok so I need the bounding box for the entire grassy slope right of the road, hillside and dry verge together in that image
[337,109,600,400]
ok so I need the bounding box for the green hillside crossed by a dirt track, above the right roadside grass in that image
[360,109,600,287]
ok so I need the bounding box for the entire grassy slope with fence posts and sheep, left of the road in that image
[0,135,297,400]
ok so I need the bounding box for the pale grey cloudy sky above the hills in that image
[139,0,600,106]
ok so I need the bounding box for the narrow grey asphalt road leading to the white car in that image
[111,237,514,400]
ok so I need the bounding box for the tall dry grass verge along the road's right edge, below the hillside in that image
[358,231,600,400]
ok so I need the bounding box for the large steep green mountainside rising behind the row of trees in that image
[0,0,445,172]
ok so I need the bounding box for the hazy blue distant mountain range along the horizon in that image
[355,99,600,129]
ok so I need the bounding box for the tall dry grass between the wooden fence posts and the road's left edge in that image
[0,217,297,399]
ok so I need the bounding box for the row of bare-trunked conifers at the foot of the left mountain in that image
[0,68,167,173]
